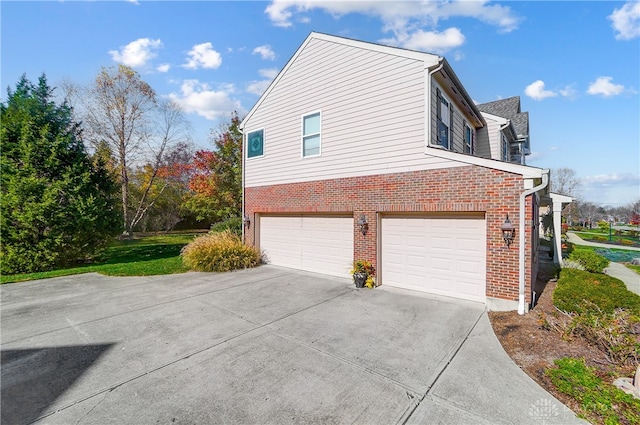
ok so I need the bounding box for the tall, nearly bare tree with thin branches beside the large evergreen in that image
[80,65,190,237]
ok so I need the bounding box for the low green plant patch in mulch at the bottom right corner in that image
[546,358,640,424]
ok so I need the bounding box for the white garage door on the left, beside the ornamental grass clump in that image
[260,216,353,277]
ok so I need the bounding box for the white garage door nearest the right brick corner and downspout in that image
[381,217,486,302]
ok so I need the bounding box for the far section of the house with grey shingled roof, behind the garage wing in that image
[476,96,531,165]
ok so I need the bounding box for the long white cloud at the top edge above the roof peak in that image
[265,0,520,52]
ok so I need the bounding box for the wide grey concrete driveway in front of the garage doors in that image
[0,266,583,424]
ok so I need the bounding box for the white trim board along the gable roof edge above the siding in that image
[239,32,441,130]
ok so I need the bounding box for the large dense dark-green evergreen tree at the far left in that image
[0,75,117,274]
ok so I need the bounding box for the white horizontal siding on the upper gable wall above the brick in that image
[244,39,464,187]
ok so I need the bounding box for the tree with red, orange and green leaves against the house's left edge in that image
[185,113,242,222]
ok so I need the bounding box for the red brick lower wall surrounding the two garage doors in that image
[245,166,533,300]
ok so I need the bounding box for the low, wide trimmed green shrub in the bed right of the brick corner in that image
[553,269,640,315]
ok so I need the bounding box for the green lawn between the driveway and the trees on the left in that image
[0,233,197,284]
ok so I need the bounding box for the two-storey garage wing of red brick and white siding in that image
[240,33,564,312]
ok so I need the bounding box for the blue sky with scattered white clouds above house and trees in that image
[0,0,640,206]
